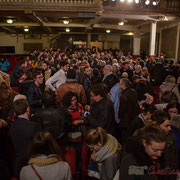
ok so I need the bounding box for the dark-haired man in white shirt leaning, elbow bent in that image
[46,60,69,92]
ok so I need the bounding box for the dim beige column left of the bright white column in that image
[133,32,141,57]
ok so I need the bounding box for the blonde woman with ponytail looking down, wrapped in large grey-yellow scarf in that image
[85,127,121,180]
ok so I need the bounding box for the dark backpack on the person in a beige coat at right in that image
[161,86,178,103]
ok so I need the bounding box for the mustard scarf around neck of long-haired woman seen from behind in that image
[28,154,59,166]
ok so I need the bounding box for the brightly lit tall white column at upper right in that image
[149,22,157,57]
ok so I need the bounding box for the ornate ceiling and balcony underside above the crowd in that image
[0,0,180,34]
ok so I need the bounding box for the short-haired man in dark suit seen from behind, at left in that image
[10,99,40,178]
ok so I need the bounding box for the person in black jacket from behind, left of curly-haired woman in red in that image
[32,90,71,144]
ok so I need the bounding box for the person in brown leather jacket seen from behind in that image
[56,69,87,104]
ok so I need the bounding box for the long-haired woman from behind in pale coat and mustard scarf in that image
[20,131,72,180]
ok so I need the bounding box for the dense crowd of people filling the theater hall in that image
[0,47,180,180]
